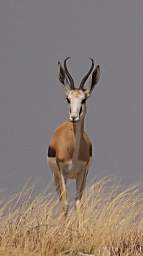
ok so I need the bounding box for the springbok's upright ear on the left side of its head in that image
[58,62,70,94]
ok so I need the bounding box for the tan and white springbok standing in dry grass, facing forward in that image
[48,57,100,215]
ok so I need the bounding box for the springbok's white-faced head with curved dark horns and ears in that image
[58,57,100,122]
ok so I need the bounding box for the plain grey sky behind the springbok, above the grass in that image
[0,0,143,192]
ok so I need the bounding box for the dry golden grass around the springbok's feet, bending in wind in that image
[0,178,143,256]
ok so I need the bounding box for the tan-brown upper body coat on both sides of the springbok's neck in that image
[48,121,92,162]
